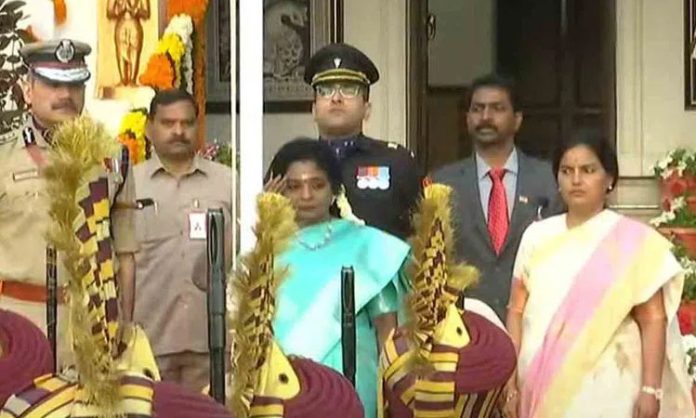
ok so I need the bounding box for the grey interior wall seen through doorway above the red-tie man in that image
[428,0,496,86]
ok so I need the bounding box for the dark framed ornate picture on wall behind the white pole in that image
[207,0,342,112]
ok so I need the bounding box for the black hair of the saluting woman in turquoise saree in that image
[264,137,343,194]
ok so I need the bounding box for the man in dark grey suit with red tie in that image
[432,74,561,319]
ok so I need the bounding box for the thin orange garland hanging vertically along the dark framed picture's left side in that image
[167,0,208,149]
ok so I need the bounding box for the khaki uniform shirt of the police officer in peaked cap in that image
[0,122,138,285]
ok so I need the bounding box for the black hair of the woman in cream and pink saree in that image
[553,128,619,189]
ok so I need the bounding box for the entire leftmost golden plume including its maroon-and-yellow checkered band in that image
[43,117,119,416]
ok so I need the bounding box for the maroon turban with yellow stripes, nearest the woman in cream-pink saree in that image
[381,312,516,418]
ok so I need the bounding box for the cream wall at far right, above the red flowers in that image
[616,0,696,176]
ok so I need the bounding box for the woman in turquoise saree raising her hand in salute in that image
[265,139,409,417]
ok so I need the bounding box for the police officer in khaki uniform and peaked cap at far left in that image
[0,39,137,367]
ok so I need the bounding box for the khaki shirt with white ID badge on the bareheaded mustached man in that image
[134,155,232,356]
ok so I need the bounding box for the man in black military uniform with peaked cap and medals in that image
[305,43,423,239]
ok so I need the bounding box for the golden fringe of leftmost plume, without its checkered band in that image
[43,116,119,417]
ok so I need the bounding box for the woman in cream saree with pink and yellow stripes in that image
[506,131,694,418]
